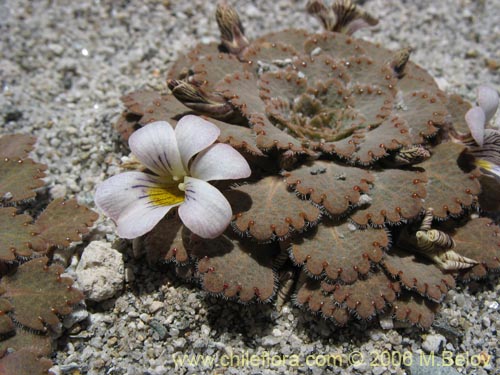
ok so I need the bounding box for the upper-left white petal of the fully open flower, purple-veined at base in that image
[128,121,186,177]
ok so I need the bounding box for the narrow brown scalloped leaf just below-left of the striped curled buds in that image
[382,248,455,302]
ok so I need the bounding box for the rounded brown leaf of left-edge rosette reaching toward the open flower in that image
[33,199,98,252]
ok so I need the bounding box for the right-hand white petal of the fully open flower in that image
[189,143,252,181]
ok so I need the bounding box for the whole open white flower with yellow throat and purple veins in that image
[95,115,251,238]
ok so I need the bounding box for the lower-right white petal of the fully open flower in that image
[179,177,232,238]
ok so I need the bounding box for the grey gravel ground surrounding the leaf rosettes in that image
[0,0,500,375]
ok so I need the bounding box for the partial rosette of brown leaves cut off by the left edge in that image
[0,134,97,375]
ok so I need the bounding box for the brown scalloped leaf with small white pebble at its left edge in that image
[351,169,427,226]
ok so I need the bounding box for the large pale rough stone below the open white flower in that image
[75,241,124,302]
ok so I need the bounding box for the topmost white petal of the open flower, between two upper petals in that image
[175,115,220,170]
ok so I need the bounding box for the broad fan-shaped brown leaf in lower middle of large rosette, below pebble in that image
[290,222,389,283]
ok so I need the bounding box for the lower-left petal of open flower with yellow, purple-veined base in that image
[94,172,184,238]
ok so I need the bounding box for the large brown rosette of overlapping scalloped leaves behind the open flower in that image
[116,1,500,328]
